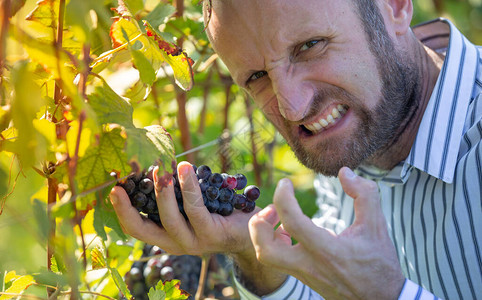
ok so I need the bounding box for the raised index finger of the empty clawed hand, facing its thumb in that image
[273,179,333,248]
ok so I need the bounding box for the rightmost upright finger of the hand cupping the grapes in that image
[177,162,213,236]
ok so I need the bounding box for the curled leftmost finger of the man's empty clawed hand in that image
[248,205,301,269]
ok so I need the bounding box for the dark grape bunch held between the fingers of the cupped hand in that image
[118,165,260,226]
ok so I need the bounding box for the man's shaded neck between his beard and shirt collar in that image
[366,40,444,170]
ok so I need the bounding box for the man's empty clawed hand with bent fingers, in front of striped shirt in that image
[249,168,405,299]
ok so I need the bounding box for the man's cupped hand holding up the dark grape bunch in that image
[110,162,260,255]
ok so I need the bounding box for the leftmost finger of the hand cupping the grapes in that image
[109,186,165,244]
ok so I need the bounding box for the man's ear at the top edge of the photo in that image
[383,0,413,35]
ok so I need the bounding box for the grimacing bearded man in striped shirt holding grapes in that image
[111,0,482,299]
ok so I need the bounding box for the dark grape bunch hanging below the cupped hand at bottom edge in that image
[124,244,201,300]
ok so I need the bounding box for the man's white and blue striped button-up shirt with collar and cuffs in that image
[236,19,482,300]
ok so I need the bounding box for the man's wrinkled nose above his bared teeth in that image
[270,72,314,122]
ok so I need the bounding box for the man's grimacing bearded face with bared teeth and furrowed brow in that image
[208,0,418,175]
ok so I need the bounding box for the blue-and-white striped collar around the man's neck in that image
[359,19,477,184]
